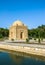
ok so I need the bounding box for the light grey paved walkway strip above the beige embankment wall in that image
[0,41,45,49]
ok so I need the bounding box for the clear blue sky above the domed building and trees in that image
[0,0,45,29]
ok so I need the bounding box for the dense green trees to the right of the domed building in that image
[28,25,45,38]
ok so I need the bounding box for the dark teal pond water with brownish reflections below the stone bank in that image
[0,52,45,65]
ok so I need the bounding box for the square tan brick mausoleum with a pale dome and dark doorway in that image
[9,20,28,40]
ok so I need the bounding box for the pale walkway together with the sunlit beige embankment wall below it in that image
[0,42,45,57]
